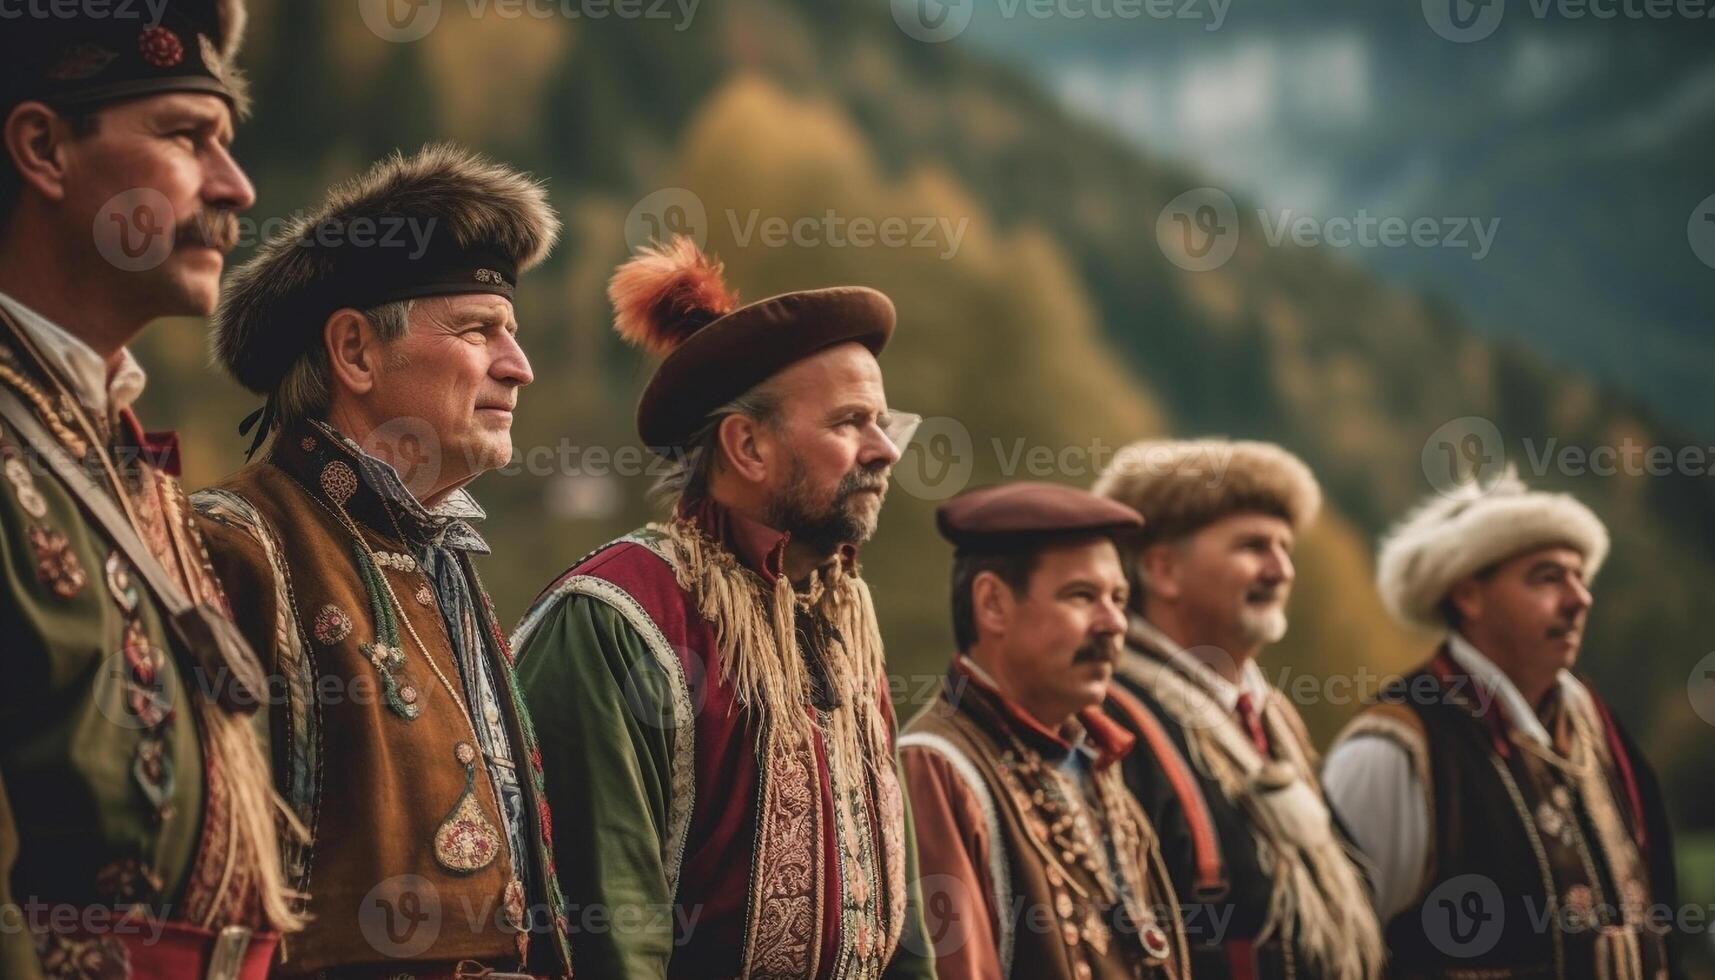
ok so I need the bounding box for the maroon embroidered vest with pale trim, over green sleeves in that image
[513,529,907,980]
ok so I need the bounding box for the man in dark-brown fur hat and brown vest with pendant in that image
[194,144,571,977]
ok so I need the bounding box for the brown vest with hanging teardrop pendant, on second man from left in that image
[196,434,569,977]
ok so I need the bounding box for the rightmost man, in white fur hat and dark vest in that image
[1324,472,1677,978]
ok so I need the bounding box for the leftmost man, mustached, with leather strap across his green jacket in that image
[0,0,305,980]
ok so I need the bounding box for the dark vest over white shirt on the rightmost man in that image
[1372,654,1665,980]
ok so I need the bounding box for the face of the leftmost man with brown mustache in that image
[63,93,256,319]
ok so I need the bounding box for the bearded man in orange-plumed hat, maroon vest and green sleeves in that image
[513,237,931,980]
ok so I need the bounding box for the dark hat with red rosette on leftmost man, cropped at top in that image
[0,0,250,117]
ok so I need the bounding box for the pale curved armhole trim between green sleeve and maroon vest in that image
[513,559,696,896]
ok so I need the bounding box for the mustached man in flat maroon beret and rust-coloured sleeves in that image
[899,482,1190,980]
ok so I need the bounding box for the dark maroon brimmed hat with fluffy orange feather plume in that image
[607,235,895,455]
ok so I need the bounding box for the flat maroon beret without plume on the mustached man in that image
[935,481,1144,551]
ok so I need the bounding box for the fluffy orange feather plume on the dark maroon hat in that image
[607,235,739,354]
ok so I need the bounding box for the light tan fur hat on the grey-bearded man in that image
[1092,439,1322,547]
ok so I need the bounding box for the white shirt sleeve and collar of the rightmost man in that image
[1322,633,1580,923]
